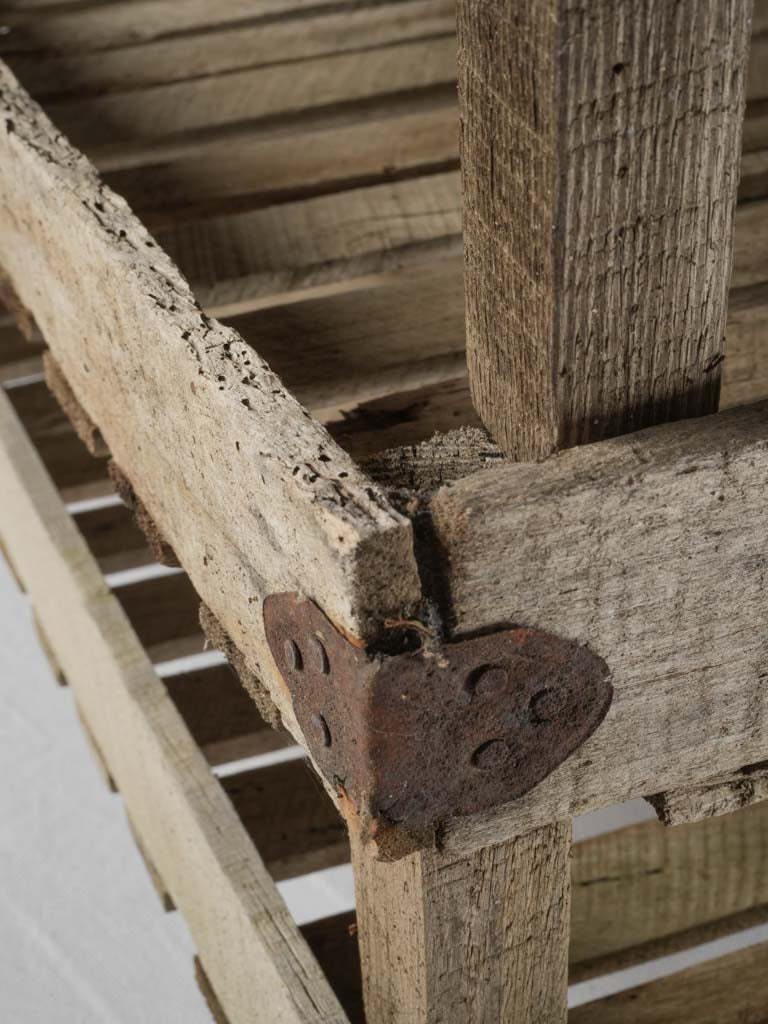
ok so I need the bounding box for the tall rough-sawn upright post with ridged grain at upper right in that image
[459,0,751,459]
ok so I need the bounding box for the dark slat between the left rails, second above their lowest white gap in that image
[163,665,289,765]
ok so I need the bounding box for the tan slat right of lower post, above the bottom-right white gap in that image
[570,805,768,981]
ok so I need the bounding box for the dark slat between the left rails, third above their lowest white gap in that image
[115,572,204,662]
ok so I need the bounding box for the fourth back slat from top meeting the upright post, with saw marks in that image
[157,172,462,312]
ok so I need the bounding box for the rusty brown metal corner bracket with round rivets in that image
[264,594,612,835]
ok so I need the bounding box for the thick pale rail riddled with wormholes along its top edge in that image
[0,64,421,757]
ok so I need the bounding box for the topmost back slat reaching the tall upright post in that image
[6,0,456,99]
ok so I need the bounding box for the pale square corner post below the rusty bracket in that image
[352,822,570,1024]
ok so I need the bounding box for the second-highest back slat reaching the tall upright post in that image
[45,36,456,154]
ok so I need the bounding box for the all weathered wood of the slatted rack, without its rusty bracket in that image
[0,0,768,1024]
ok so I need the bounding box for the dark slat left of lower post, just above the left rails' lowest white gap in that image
[221,761,349,882]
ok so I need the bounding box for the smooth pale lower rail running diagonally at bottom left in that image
[0,385,345,1024]
